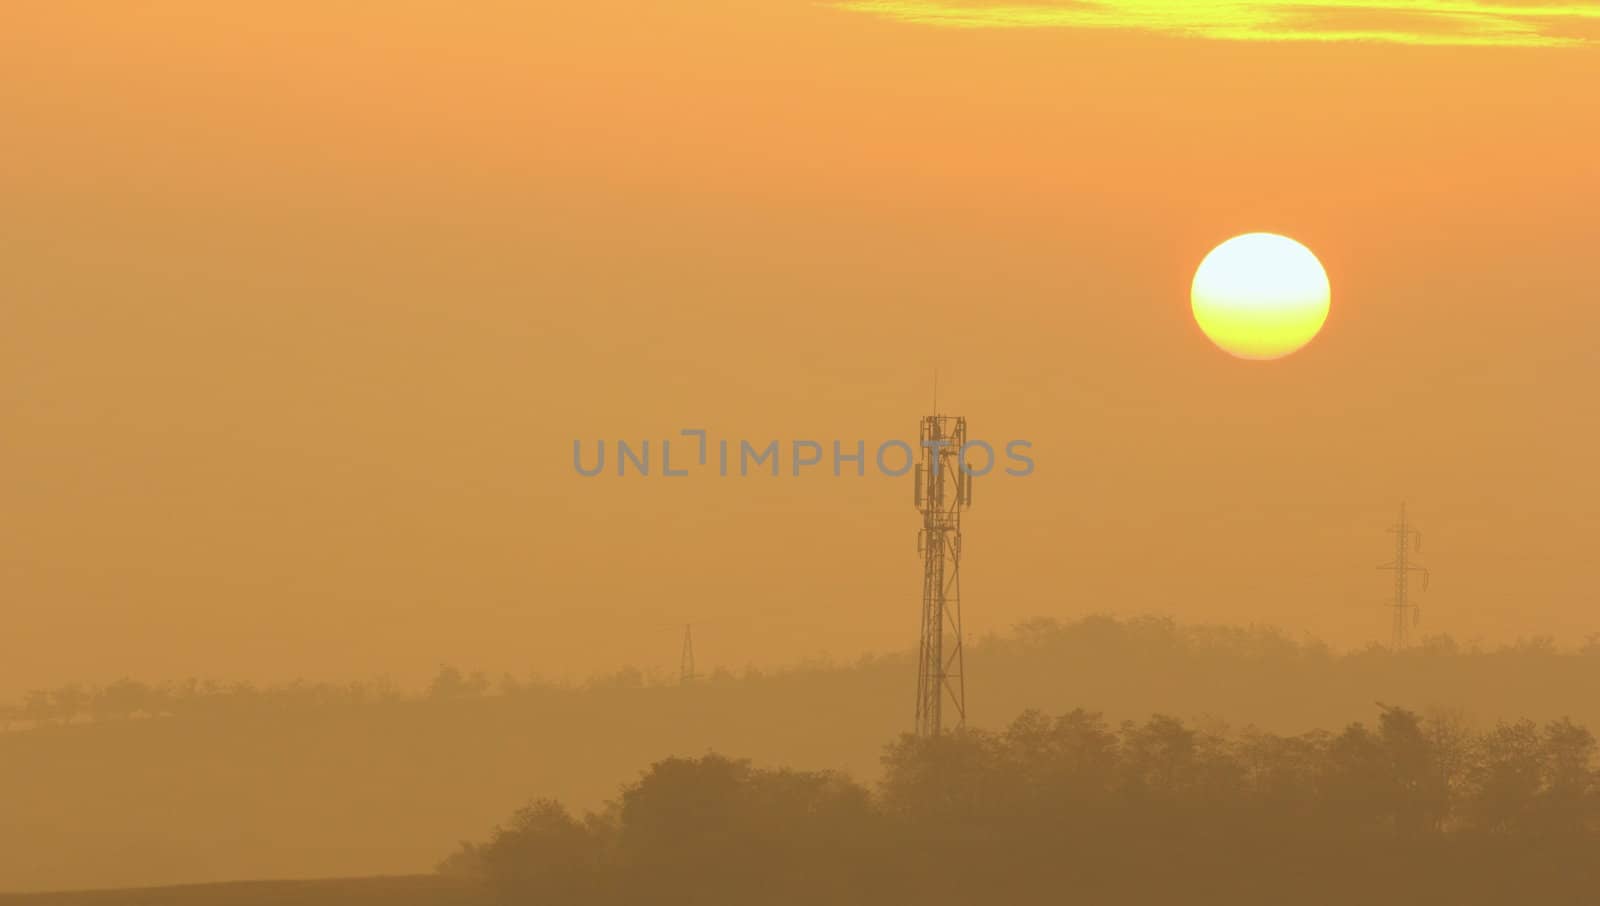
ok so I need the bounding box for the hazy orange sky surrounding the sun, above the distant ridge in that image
[0,0,1600,695]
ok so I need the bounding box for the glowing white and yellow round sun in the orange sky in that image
[1189,232,1331,359]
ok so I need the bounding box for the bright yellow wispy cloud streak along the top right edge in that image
[835,0,1600,46]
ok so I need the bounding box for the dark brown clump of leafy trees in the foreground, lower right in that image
[440,706,1600,904]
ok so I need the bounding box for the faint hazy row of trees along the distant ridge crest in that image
[9,616,1600,732]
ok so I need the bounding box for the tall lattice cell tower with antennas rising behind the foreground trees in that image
[914,415,973,736]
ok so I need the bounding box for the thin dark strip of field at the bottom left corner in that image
[0,874,490,906]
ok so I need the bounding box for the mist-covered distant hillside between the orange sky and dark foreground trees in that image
[0,618,1600,890]
